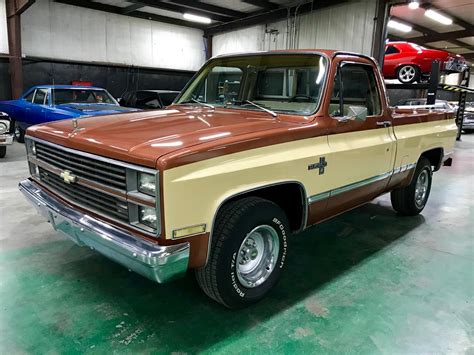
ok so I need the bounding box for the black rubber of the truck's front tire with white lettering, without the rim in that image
[196,197,290,308]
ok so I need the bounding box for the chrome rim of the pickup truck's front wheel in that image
[236,225,280,288]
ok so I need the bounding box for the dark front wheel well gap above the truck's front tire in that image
[228,183,306,232]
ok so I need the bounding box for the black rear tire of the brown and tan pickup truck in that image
[390,157,433,216]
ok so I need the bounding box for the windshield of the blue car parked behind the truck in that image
[52,89,117,105]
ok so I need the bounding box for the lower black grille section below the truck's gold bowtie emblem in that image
[39,167,129,223]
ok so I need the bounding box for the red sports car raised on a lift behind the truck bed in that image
[383,42,467,84]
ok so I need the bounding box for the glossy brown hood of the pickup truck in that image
[28,106,300,167]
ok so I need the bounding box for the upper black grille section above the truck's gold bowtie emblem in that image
[36,142,127,190]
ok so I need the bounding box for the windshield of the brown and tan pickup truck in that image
[176,54,327,115]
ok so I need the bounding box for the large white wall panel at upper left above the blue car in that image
[20,0,205,70]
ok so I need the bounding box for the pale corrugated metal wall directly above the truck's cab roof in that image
[213,0,376,55]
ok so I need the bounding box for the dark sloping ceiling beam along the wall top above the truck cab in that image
[204,0,349,35]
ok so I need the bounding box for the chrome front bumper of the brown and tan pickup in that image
[19,179,189,283]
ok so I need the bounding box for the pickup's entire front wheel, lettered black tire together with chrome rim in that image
[196,197,290,308]
